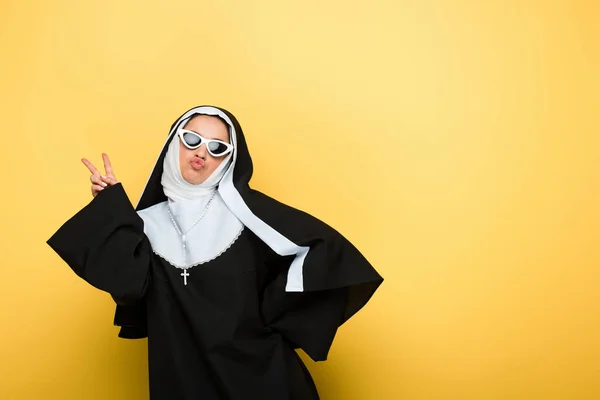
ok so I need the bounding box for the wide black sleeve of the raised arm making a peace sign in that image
[47,184,152,304]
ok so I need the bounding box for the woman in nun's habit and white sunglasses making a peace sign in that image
[48,106,383,400]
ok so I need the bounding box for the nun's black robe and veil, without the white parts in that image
[48,109,383,400]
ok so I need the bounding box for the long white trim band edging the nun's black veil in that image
[140,107,310,292]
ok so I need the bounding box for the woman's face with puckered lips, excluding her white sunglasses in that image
[179,115,229,185]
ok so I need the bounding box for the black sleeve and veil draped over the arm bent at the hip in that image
[254,193,383,361]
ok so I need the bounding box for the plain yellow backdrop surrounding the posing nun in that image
[0,0,600,400]
